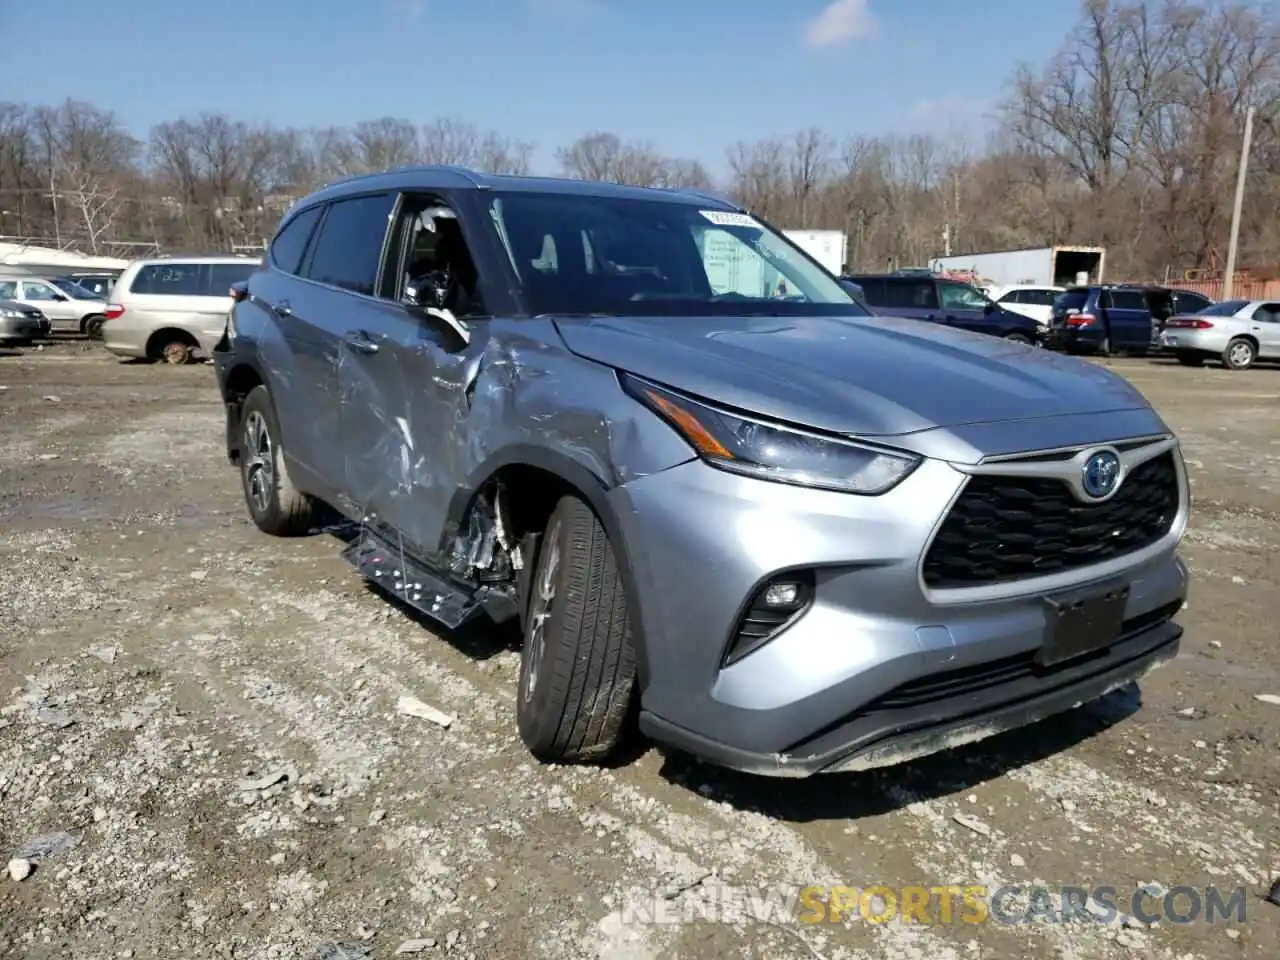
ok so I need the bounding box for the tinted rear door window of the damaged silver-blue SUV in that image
[307,193,396,297]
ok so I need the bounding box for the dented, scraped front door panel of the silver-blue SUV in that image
[338,301,488,562]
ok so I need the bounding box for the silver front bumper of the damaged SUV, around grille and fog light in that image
[609,440,1187,776]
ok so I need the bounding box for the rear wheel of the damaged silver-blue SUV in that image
[239,385,320,536]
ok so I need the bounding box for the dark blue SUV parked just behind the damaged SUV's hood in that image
[849,271,1042,343]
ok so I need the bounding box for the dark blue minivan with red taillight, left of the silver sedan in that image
[1047,284,1212,355]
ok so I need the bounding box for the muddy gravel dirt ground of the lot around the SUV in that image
[0,343,1280,960]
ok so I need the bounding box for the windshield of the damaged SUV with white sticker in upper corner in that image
[489,192,868,316]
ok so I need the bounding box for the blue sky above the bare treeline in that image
[0,0,1079,173]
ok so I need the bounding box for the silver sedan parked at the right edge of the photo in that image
[1160,300,1280,370]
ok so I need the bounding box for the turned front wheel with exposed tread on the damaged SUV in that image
[516,497,636,763]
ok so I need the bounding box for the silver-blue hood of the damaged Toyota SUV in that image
[556,316,1149,436]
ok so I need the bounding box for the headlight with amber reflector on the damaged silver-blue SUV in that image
[618,374,920,497]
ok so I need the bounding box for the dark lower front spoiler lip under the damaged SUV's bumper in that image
[640,621,1183,777]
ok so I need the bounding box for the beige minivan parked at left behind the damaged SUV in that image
[102,256,257,364]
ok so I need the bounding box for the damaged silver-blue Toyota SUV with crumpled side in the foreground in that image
[215,168,1188,776]
